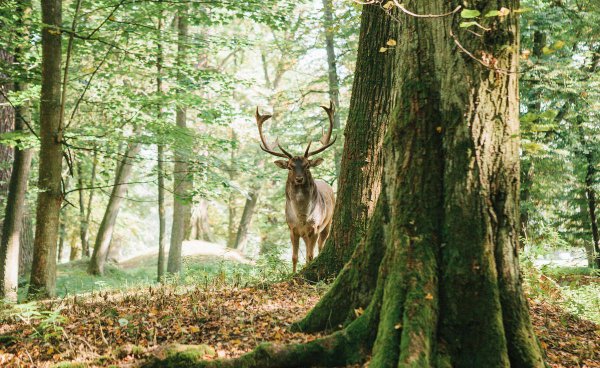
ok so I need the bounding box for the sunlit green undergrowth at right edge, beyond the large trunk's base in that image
[524,265,600,324]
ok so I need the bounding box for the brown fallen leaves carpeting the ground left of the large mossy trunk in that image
[0,283,322,367]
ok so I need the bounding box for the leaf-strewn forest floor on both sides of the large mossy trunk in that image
[0,268,600,368]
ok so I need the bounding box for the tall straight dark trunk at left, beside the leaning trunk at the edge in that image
[29,0,63,298]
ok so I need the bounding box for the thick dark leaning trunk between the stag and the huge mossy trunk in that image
[301,2,400,281]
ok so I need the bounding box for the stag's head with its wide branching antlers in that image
[256,101,337,185]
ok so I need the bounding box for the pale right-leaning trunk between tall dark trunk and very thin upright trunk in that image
[88,142,141,275]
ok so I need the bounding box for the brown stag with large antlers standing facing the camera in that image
[256,102,337,273]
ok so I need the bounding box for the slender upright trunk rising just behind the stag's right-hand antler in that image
[323,0,341,177]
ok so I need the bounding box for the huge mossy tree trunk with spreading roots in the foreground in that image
[151,0,544,368]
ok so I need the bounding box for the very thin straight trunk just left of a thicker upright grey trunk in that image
[156,5,167,282]
